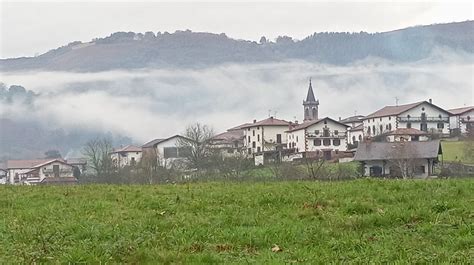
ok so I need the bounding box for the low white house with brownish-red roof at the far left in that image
[7,159,77,184]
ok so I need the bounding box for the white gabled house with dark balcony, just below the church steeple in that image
[287,117,349,160]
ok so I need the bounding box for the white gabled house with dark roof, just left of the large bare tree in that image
[142,135,192,168]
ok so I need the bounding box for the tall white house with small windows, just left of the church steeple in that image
[242,117,290,155]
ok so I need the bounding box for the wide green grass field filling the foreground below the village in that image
[0,179,474,264]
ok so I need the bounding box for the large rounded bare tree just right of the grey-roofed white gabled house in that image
[178,123,214,169]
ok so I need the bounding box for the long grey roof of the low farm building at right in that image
[354,140,442,161]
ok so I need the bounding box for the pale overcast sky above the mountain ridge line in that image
[0,0,474,58]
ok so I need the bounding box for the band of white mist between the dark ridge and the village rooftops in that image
[0,53,474,143]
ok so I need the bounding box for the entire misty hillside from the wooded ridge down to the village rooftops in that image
[0,21,474,160]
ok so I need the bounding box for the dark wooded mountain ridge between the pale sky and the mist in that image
[0,21,474,71]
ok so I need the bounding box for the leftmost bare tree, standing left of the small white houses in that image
[83,138,114,177]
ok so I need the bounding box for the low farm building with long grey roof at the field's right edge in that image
[354,140,442,178]
